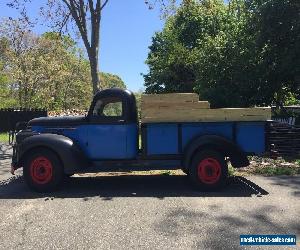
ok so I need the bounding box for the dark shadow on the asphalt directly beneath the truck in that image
[0,175,268,200]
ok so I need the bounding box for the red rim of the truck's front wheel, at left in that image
[30,157,53,184]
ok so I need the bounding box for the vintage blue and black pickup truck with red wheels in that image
[11,88,282,192]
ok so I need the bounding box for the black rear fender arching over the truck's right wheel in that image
[182,135,250,169]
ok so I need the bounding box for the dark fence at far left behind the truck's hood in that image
[0,108,47,132]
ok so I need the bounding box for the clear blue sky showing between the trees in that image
[0,0,164,91]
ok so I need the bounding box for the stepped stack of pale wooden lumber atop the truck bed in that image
[141,93,271,123]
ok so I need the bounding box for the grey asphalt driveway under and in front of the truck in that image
[0,145,300,249]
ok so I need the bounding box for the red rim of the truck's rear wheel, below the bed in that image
[198,158,221,184]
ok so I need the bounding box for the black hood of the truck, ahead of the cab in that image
[28,116,87,127]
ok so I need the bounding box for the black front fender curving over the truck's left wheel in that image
[16,134,89,174]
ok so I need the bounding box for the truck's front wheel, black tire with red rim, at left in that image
[23,148,64,192]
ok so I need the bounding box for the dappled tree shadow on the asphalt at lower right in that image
[155,204,300,249]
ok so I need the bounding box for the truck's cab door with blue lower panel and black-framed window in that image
[87,92,138,160]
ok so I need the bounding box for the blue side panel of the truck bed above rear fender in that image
[145,122,266,156]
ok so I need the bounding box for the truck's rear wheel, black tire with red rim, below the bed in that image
[189,150,228,191]
